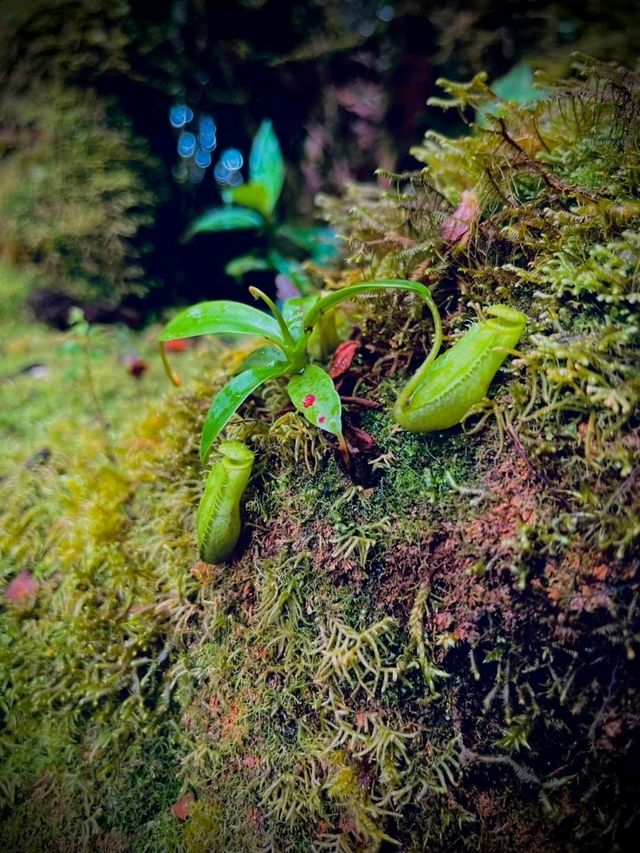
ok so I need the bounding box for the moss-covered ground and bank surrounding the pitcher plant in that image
[0,56,640,853]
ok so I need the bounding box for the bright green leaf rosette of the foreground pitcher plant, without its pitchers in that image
[160,279,439,464]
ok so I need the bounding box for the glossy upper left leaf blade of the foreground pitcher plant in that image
[160,299,284,347]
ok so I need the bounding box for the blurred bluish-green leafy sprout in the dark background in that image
[185,120,338,294]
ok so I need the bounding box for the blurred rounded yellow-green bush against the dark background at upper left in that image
[0,84,161,303]
